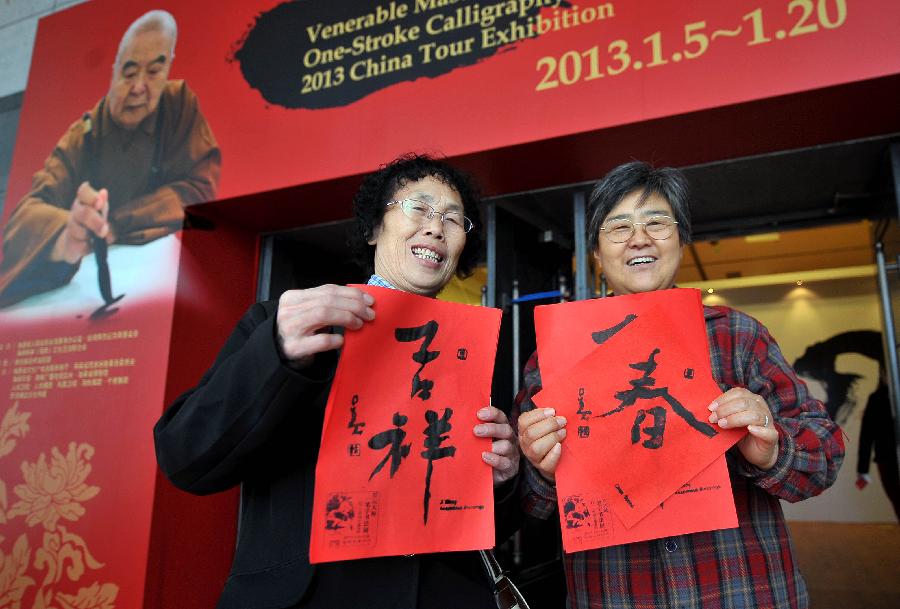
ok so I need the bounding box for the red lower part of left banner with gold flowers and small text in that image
[0,262,178,607]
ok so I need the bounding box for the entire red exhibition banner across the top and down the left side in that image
[0,0,900,607]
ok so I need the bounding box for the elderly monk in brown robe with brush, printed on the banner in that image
[0,10,221,314]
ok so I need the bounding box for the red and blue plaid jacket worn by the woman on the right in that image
[516,307,844,609]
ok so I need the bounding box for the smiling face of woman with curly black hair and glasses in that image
[369,176,466,296]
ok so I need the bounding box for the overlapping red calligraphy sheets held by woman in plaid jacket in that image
[535,289,740,552]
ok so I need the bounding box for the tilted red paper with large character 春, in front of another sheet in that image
[535,307,743,527]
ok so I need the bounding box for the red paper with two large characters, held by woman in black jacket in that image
[310,286,501,563]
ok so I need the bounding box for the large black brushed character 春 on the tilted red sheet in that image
[599,349,718,449]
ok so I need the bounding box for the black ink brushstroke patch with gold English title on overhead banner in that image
[232,0,568,109]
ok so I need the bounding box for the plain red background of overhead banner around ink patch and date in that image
[5,0,900,222]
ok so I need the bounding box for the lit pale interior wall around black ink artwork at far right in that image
[704,277,896,522]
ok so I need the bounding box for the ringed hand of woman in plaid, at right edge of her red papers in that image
[709,387,778,469]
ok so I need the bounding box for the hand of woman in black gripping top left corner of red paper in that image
[275,284,375,369]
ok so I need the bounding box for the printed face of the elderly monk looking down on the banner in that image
[109,30,172,130]
